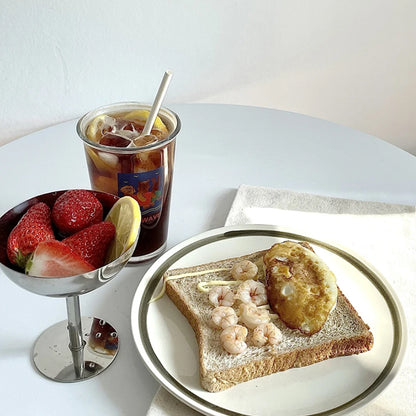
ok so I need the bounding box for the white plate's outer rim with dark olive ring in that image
[131,224,407,416]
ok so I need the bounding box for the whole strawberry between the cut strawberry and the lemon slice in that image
[63,221,116,269]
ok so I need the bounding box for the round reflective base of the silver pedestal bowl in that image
[32,317,119,383]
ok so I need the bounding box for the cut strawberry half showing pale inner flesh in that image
[26,240,95,277]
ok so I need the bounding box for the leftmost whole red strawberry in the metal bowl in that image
[7,202,55,268]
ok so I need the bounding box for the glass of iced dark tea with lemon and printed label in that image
[77,102,181,262]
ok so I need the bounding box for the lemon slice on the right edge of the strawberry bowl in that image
[105,196,141,263]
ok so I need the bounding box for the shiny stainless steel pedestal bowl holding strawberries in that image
[0,190,137,382]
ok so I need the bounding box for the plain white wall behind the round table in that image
[0,0,416,154]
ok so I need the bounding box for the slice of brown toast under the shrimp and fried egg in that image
[164,251,373,392]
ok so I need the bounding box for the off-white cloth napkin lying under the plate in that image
[147,185,416,416]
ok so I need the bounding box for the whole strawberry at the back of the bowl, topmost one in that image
[52,189,103,235]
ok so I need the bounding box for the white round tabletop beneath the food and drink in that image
[0,104,416,416]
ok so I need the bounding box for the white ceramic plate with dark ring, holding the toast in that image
[131,225,406,416]
